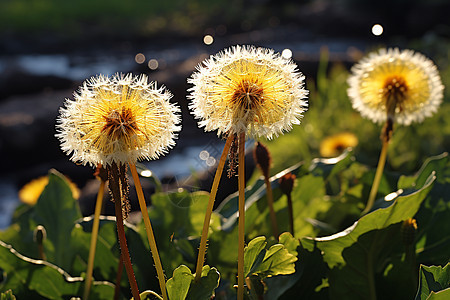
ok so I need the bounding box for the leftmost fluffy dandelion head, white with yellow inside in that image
[56,74,180,167]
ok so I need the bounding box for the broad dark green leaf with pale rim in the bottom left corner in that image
[0,241,114,300]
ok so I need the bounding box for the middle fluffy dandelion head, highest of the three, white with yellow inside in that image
[188,46,308,139]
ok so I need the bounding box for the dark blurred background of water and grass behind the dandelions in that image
[0,0,450,228]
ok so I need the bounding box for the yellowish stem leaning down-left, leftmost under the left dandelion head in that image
[83,180,105,300]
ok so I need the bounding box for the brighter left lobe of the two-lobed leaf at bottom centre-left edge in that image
[166,265,194,300]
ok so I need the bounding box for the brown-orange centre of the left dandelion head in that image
[102,107,139,140]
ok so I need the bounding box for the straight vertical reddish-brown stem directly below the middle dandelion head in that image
[237,132,245,300]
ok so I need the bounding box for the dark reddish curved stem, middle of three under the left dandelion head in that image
[114,186,140,299]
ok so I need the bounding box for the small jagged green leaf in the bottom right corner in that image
[416,263,450,300]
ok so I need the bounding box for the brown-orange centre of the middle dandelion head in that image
[231,80,264,111]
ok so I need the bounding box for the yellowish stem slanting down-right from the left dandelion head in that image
[129,163,168,300]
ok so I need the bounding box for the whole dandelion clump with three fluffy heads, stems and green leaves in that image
[0,46,450,300]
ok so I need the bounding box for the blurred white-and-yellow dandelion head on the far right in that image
[348,48,444,125]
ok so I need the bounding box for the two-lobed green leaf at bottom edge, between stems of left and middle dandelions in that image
[166,265,220,300]
